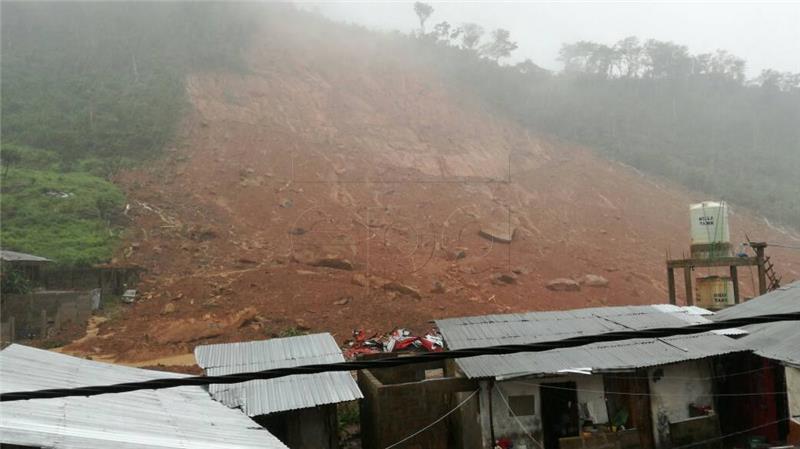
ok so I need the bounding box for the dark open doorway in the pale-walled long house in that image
[539,382,580,449]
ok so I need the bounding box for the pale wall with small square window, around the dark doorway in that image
[488,374,608,449]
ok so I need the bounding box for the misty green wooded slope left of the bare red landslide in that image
[0,2,253,265]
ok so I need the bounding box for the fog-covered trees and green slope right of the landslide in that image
[409,3,800,227]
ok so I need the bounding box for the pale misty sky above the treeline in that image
[304,2,800,77]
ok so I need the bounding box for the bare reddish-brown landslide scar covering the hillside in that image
[67,10,800,361]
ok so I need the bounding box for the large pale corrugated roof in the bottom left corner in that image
[0,345,286,449]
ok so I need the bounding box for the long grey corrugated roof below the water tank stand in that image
[437,305,746,378]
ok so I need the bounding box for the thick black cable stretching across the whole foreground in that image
[0,311,800,402]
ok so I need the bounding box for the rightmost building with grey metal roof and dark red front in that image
[712,282,800,447]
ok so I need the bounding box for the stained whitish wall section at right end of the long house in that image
[647,359,713,449]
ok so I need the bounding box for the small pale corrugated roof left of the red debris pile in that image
[194,333,363,416]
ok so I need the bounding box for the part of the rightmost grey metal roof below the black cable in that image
[738,321,800,368]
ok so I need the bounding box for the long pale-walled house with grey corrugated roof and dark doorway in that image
[437,305,746,449]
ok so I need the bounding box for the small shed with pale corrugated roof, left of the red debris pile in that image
[194,333,363,449]
